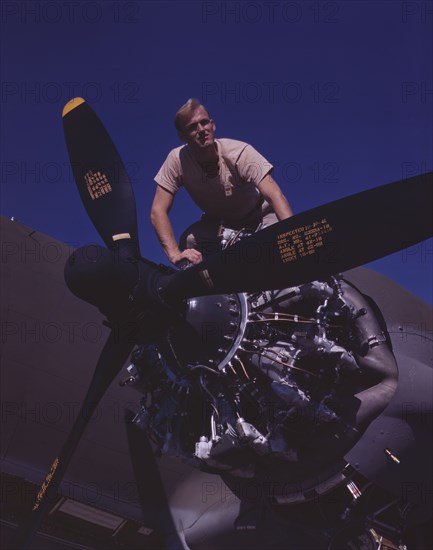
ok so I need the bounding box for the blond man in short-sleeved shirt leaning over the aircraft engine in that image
[151,99,292,264]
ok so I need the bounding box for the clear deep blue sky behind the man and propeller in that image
[0,0,433,302]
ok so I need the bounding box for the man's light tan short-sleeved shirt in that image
[155,138,273,222]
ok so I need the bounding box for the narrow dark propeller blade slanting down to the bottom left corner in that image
[11,327,134,550]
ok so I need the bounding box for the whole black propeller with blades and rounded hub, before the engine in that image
[14,98,433,548]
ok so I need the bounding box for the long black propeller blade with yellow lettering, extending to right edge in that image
[160,172,433,303]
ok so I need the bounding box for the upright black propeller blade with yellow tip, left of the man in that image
[62,97,139,254]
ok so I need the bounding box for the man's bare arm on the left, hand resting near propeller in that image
[150,185,202,264]
